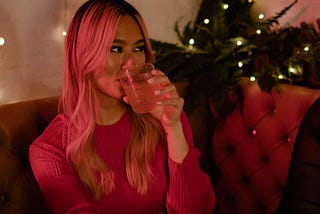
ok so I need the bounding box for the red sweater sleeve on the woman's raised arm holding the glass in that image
[166,113,216,214]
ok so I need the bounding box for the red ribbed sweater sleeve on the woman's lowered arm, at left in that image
[29,115,97,214]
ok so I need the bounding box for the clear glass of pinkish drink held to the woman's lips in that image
[118,63,163,113]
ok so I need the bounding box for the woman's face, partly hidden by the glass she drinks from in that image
[95,15,146,99]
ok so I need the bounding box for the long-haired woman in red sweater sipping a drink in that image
[29,0,215,213]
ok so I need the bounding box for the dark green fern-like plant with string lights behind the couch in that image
[152,0,320,115]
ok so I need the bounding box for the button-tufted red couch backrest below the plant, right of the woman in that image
[211,79,320,214]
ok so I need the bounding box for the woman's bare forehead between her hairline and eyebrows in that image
[115,15,143,41]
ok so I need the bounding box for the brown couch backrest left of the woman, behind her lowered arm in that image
[0,97,58,214]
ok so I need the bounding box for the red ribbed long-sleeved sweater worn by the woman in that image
[29,113,216,214]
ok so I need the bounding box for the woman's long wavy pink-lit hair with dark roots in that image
[59,0,164,200]
